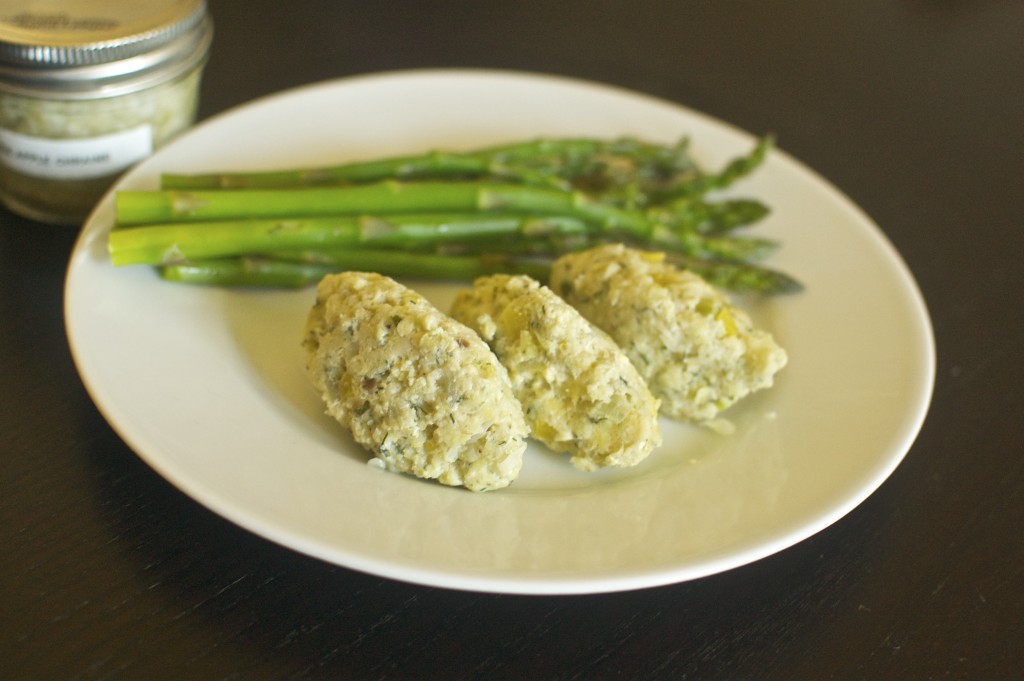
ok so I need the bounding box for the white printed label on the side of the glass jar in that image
[0,125,153,180]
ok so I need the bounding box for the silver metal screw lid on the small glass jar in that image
[0,0,212,98]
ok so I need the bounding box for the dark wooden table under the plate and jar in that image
[0,0,1024,681]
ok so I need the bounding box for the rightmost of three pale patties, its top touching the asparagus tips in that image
[550,244,787,422]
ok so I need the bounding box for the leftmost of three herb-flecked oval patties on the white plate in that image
[303,271,529,492]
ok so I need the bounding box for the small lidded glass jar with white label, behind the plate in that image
[0,0,213,224]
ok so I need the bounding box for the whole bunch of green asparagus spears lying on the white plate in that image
[109,137,800,293]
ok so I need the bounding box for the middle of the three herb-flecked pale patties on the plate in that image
[452,274,662,470]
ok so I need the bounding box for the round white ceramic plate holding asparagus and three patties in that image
[66,66,935,594]
